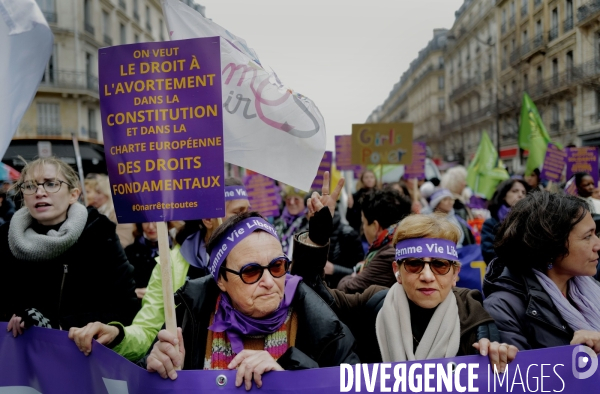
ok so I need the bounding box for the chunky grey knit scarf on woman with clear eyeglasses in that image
[8,202,87,261]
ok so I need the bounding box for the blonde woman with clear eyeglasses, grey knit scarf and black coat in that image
[0,158,137,336]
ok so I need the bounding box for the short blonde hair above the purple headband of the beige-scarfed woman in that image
[392,214,460,245]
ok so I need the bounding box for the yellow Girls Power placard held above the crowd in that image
[352,123,413,165]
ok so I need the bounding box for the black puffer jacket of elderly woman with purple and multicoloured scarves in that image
[164,276,360,370]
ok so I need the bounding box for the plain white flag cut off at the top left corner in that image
[0,0,54,158]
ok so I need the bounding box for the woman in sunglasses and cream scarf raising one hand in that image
[292,205,517,371]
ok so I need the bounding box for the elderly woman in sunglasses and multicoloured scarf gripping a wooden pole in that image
[146,211,359,390]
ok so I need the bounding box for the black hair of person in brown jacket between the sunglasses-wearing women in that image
[360,189,412,228]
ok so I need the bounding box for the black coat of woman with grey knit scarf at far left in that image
[0,208,138,330]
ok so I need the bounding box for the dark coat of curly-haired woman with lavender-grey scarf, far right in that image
[483,259,574,350]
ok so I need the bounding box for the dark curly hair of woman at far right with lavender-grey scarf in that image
[494,191,589,272]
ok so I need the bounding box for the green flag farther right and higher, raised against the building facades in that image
[519,92,550,175]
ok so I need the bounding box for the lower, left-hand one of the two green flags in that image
[467,131,509,200]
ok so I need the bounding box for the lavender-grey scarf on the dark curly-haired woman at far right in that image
[533,270,600,331]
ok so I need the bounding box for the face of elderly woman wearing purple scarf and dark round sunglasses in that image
[217,231,285,318]
